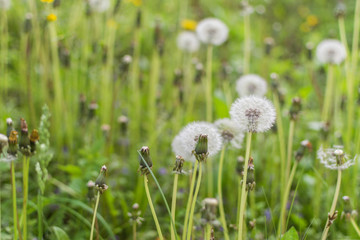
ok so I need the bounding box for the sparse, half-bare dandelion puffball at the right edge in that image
[316,146,357,170]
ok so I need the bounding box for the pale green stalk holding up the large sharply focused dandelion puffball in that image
[237,132,252,240]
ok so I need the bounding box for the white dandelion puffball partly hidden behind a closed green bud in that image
[171,122,222,162]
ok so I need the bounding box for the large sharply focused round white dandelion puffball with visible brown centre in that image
[230,96,276,132]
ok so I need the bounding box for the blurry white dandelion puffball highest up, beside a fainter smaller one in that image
[196,18,229,46]
